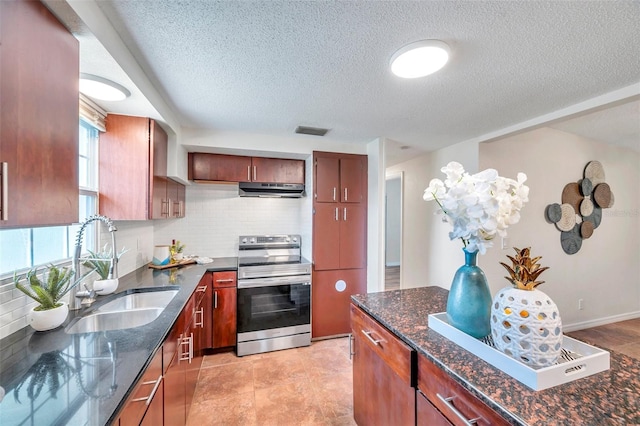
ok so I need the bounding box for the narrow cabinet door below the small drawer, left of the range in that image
[213,286,238,348]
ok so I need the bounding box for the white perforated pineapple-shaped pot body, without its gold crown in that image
[491,287,562,368]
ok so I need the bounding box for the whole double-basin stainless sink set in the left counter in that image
[65,288,178,334]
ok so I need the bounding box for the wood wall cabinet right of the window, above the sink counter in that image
[99,114,175,220]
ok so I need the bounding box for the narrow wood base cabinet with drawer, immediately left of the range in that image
[211,271,238,349]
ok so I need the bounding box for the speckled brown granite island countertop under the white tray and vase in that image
[352,287,640,426]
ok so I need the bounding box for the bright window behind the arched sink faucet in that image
[0,119,98,278]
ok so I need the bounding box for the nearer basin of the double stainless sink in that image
[65,308,164,334]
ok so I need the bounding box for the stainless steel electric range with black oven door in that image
[237,235,311,356]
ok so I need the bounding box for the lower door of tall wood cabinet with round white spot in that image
[311,269,367,338]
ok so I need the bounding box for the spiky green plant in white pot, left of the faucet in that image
[13,265,82,331]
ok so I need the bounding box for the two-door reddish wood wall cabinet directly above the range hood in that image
[189,152,304,184]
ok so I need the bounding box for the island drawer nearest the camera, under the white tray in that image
[418,355,509,426]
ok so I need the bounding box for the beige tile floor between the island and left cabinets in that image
[187,337,355,426]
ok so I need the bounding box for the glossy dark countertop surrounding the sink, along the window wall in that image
[0,257,237,426]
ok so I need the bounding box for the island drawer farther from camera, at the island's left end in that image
[351,305,415,386]
